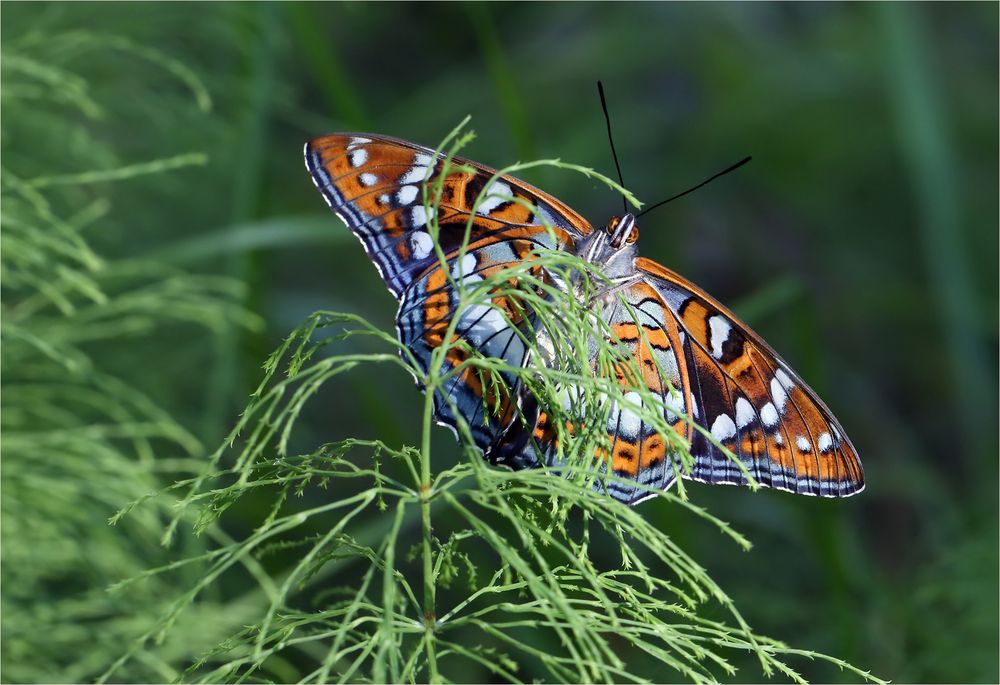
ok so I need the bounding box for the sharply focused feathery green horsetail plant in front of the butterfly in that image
[102,124,877,682]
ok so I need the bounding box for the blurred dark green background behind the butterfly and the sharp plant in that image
[0,3,1000,682]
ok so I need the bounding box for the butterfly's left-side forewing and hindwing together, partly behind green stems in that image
[305,133,591,450]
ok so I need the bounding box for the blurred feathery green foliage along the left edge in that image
[0,25,255,682]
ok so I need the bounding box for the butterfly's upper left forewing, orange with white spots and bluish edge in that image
[305,134,590,296]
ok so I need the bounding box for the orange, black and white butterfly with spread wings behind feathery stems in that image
[305,133,864,504]
